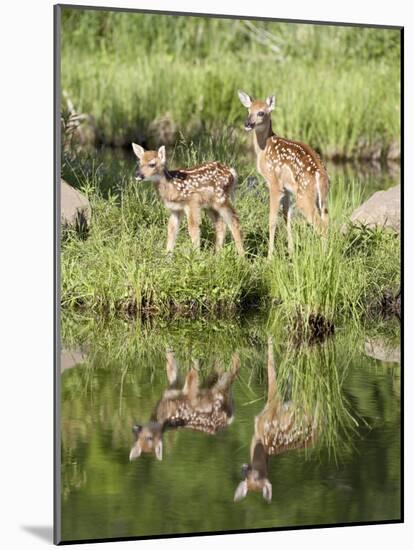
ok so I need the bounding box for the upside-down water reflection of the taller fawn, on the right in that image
[234,338,317,502]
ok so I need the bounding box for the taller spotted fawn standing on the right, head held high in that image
[239,91,329,257]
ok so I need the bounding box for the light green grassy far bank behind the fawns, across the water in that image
[62,9,400,157]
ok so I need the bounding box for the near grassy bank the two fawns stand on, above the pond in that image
[61,144,400,332]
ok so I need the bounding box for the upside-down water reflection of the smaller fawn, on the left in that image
[129,350,239,460]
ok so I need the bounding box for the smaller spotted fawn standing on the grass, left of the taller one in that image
[132,147,244,256]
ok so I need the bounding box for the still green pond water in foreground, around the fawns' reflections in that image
[61,317,400,540]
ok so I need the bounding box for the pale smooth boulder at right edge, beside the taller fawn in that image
[351,185,401,233]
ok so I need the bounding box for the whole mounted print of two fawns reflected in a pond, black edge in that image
[55,5,403,544]
